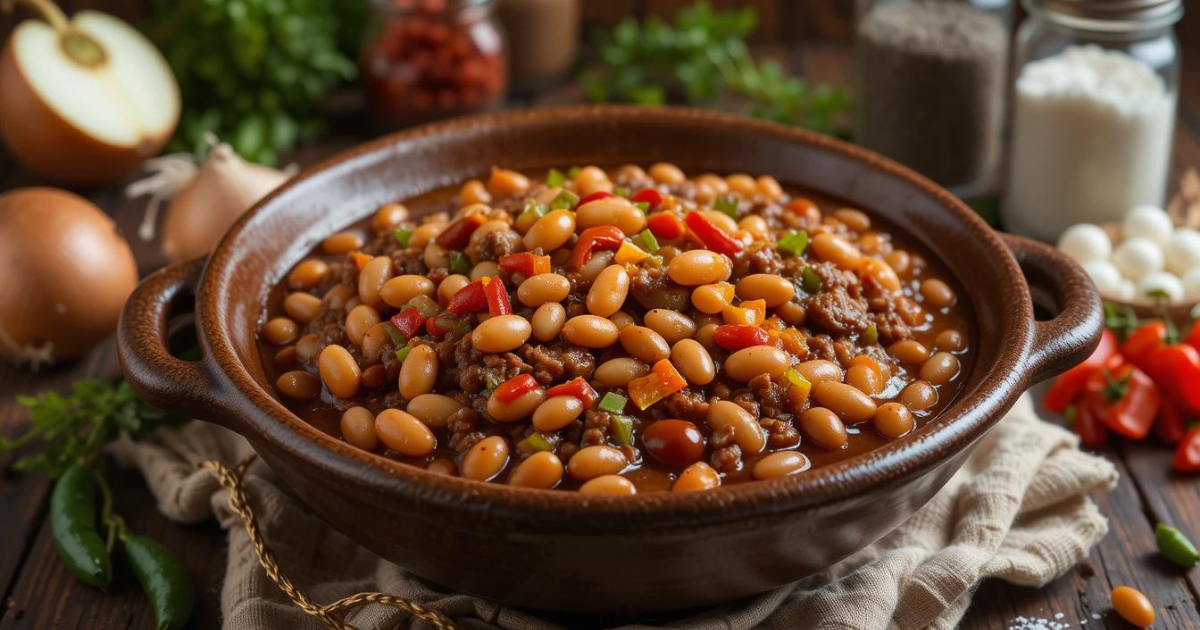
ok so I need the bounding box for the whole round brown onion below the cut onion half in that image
[0,188,138,360]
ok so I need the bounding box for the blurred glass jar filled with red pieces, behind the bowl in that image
[361,0,508,128]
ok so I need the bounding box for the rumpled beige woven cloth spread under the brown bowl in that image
[116,396,1117,630]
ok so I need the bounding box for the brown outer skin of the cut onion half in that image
[0,14,178,187]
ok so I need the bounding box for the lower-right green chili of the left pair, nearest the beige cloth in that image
[122,535,196,630]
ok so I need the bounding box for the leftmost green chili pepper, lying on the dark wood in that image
[50,463,113,588]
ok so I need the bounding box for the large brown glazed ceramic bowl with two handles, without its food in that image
[119,107,1102,612]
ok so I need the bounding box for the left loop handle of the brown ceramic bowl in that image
[116,257,238,424]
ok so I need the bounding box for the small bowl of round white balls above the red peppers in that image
[1058,205,1200,307]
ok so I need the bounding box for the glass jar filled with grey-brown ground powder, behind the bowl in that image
[854,0,1013,197]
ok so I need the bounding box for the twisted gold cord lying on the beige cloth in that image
[200,456,457,630]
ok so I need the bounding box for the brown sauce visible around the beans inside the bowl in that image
[258,174,977,492]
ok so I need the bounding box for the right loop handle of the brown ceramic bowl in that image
[1000,234,1104,384]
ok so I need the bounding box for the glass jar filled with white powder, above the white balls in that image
[1002,0,1183,241]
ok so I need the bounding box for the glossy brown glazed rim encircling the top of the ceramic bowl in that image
[196,106,1033,533]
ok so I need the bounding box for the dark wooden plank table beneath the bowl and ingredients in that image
[0,41,1200,630]
